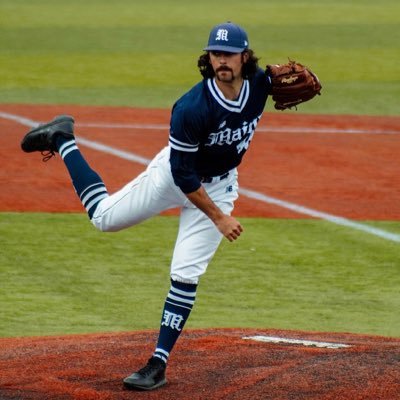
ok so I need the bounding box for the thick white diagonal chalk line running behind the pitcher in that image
[0,111,400,243]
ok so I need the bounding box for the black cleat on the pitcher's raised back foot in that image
[21,115,75,157]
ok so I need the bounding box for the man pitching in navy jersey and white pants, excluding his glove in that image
[21,22,320,390]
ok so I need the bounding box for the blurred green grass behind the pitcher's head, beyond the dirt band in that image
[0,0,400,115]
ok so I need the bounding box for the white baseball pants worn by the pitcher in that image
[92,147,238,284]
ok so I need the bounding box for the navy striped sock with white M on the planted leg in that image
[153,280,197,363]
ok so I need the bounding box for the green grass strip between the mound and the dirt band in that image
[0,213,400,336]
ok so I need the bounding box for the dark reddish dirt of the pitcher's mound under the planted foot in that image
[0,329,400,400]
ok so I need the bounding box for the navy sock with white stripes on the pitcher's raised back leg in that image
[56,135,108,219]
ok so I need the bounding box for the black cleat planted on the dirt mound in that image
[124,357,167,390]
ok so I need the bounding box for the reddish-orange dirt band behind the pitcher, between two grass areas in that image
[0,105,400,220]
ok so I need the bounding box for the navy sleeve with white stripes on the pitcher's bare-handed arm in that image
[169,102,202,193]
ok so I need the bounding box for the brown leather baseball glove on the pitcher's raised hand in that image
[266,60,322,110]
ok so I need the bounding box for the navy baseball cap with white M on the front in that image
[204,22,249,53]
